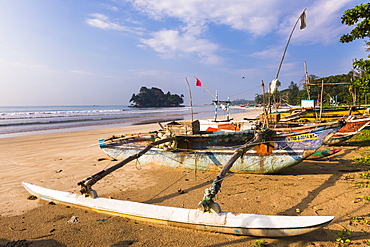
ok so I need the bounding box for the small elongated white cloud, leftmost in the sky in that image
[85,13,144,35]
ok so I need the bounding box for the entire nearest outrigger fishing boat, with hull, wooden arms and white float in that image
[22,11,339,237]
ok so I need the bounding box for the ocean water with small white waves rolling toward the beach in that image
[0,105,244,138]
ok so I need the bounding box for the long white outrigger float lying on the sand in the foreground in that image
[22,182,334,237]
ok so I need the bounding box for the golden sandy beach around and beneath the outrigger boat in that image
[0,110,370,247]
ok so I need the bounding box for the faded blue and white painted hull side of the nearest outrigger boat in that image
[100,128,337,174]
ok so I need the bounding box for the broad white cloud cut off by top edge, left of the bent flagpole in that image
[128,0,286,35]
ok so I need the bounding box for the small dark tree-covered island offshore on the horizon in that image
[130,87,184,107]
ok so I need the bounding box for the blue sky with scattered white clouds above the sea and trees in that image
[0,0,367,106]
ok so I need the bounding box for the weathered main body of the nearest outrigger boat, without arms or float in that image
[100,121,341,174]
